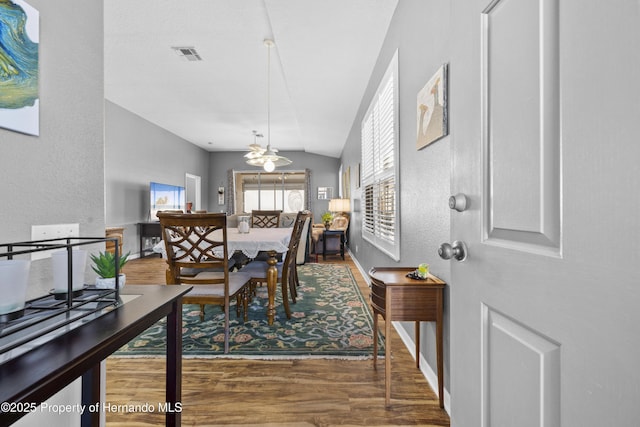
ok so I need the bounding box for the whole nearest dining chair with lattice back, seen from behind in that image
[158,212,251,353]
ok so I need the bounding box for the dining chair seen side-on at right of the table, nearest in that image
[240,211,311,319]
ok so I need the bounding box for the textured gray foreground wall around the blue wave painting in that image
[0,0,105,297]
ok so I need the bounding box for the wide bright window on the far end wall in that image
[235,172,307,213]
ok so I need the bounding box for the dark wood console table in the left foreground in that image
[0,285,190,426]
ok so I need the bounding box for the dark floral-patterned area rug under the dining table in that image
[115,263,384,359]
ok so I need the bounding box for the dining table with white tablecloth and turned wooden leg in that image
[214,227,293,325]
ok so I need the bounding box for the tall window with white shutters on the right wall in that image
[361,51,400,261]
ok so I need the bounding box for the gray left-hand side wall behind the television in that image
[105,100,210,254]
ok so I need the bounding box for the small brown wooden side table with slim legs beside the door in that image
[369,267,445,408]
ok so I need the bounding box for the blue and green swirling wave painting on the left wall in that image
[0,0,40,135]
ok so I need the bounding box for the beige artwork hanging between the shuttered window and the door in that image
[416,64,449,150]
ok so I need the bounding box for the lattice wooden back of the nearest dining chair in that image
[158,212,229,284]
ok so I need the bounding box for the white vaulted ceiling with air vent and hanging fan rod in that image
[104,0,397,157]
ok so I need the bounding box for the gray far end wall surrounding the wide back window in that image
[208,151,340,222]
